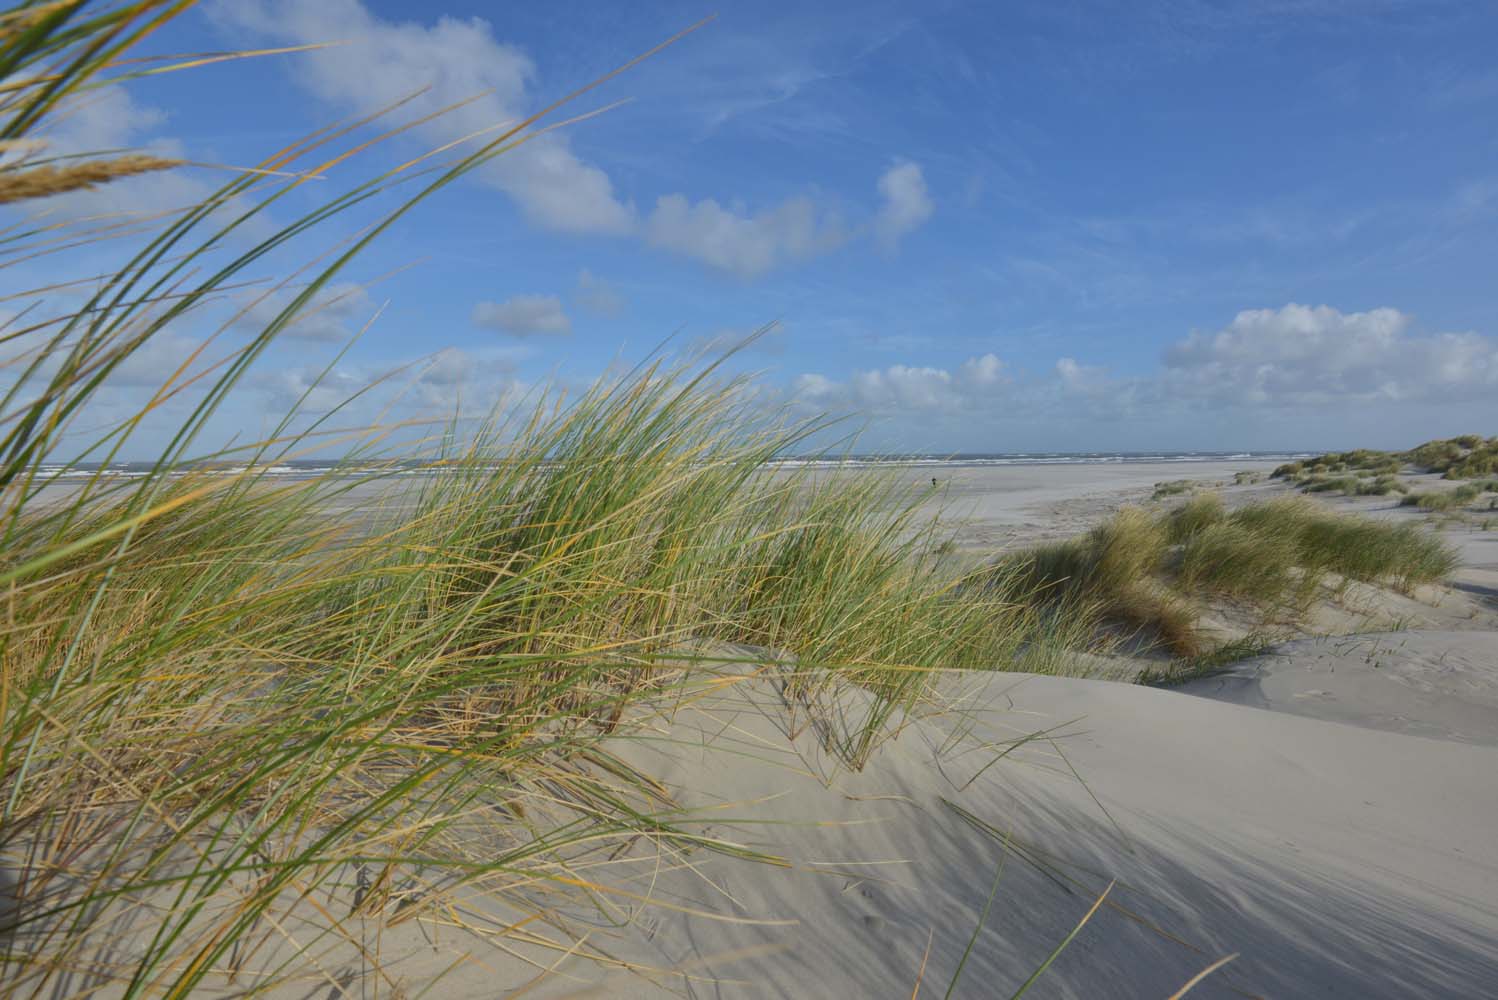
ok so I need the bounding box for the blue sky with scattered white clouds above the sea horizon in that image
[0,0,1498,457]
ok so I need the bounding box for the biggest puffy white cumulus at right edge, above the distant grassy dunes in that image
[1161,302,1498,404]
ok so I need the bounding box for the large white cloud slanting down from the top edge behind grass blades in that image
[211,0,635,234]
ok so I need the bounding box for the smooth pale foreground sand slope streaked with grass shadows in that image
[482,664,1498,997]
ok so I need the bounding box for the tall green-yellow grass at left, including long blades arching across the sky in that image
[0,0,1089,997]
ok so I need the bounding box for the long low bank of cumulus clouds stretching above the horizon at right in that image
[792,304,1498,445]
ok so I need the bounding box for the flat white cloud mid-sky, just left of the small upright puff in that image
[646,195,848,278]
